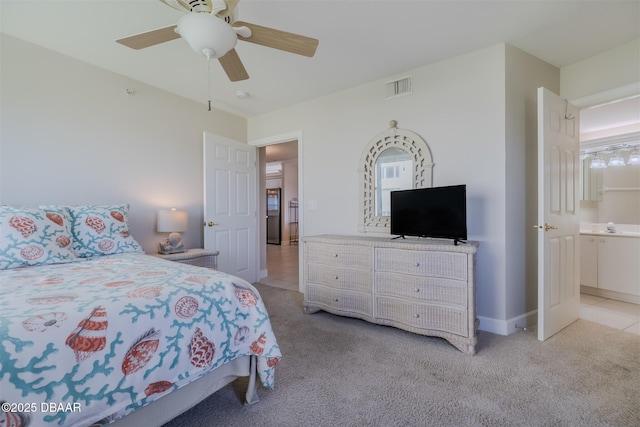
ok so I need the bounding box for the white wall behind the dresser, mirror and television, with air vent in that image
[248,44,506,327]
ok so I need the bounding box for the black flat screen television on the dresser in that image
[390,185,467,245]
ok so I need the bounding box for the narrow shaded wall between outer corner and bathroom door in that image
[504,45,560,322]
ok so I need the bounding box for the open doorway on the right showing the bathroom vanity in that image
[580,93,640,335]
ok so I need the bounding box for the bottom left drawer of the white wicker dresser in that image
[305,283,373,317]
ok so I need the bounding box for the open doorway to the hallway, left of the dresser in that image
[258,140,300,291]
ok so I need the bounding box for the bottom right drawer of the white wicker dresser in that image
[376,297,469,337]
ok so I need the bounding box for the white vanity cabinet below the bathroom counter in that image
[580,233,640,301]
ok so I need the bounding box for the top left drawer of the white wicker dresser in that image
[306,242,372,270]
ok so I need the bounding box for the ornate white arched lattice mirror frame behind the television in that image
[358,120,433,233]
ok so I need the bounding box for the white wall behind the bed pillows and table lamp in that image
[0,35,246,252]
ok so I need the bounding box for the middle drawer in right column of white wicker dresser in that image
[374,272,468,309]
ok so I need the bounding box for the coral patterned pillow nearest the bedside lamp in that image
[70,204,143,258]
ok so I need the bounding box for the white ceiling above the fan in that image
[0,0,640,121]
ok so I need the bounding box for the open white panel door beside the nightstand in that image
[204,132,258,283]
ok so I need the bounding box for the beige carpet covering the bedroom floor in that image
[166,284,640,427]
